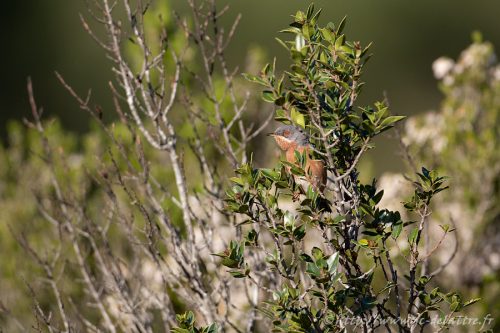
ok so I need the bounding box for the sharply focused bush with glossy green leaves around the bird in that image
[222,6,476,332]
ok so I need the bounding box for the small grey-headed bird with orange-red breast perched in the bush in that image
[270,125,327,193]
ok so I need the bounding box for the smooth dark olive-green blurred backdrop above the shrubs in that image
[0,0,500,173]
